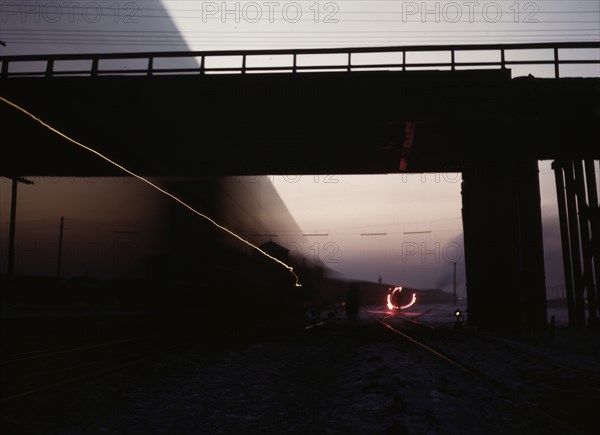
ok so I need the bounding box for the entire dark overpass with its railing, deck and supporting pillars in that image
[0,43,600,328]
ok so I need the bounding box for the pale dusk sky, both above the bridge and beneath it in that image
[0,0,600,294]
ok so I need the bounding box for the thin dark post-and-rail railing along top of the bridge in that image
[0,42,600,78]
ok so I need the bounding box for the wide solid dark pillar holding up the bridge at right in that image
[462,160,547,329]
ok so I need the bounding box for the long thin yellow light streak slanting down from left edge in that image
[0,96,302,287]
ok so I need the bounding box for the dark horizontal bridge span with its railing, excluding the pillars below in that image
[0,43,600,176]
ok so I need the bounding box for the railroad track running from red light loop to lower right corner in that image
[372,314,600,434]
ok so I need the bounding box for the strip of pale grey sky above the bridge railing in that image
[0,0,600,54]
